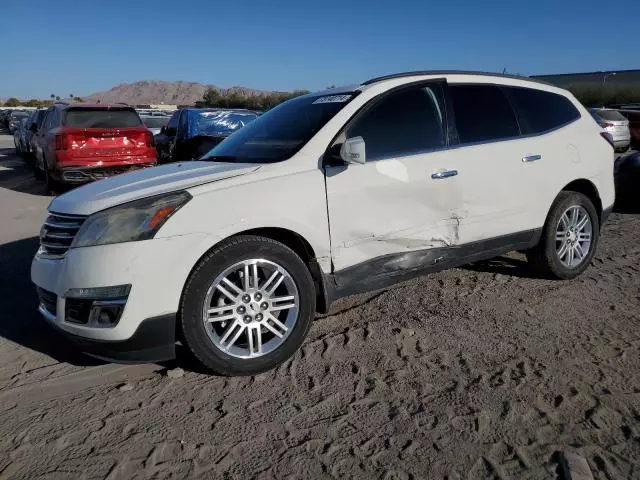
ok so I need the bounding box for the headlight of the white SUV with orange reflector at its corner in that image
[71,192,191,248]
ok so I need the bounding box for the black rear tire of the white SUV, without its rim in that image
[527,191,600,280]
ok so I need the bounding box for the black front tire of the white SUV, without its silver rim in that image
[180,235,316,376]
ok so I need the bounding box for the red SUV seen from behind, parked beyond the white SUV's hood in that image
[34,103,157,192]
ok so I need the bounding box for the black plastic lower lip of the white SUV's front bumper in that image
[39,307,176,363]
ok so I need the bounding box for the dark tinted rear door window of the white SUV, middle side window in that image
[450,85,520,143]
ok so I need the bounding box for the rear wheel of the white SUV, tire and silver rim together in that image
[527,191,600,280]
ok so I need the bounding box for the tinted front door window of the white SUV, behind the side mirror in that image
[346,84,446,160]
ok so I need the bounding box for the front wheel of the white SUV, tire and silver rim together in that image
[181,236,316,375]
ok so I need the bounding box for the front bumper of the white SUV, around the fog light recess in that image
[31,233,206,362]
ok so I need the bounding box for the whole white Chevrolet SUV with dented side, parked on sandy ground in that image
[31,72,614,375]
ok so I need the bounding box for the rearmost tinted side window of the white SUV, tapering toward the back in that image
[508,87,580,134]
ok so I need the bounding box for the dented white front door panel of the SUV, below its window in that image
[326,151,468,270]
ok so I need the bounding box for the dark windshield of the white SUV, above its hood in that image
[202,93,355,163]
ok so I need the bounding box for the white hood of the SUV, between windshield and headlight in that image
[49,162,260,215]
